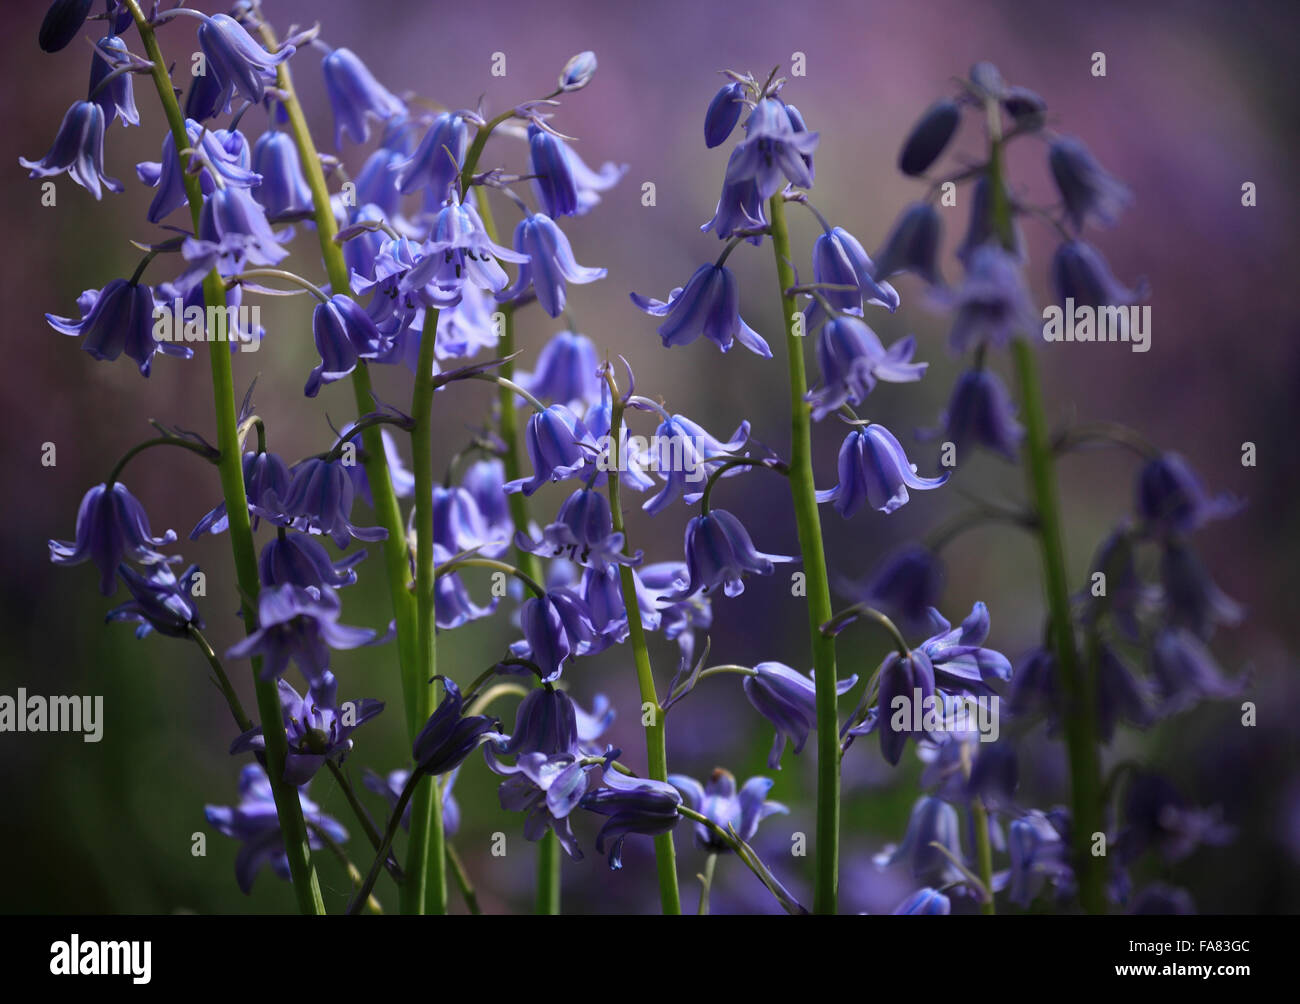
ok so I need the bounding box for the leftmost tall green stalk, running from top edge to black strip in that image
[126,0,325,914]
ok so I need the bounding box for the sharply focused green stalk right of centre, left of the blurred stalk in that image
[768,192,840,913]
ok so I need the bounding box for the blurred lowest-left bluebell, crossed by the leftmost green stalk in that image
[203,763,347,895]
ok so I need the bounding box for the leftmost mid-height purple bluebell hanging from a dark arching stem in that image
[49,481,176,596]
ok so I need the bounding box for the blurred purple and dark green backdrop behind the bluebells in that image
[0,0,1300,913]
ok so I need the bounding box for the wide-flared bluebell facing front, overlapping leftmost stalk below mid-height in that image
[226,585,376,683]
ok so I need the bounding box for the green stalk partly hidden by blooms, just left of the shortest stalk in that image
[475,189,560,917]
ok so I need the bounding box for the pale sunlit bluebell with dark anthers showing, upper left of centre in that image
[399,202,528,307]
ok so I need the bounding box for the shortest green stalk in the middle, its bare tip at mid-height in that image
[606,380,681,914]
